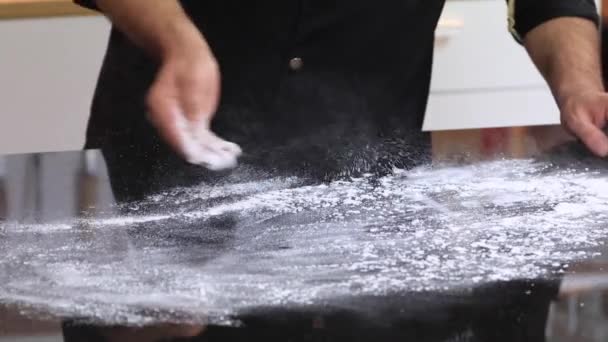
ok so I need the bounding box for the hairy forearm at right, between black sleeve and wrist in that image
[524,17,604,106]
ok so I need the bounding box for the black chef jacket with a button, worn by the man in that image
[76,0,597,195]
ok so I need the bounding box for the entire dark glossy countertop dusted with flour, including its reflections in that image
[0,149,608,342]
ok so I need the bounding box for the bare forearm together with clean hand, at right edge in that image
[525,18,608,157]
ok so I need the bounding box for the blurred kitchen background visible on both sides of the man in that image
[0,0,601,159]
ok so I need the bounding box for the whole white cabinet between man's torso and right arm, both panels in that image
[423,0,559,131]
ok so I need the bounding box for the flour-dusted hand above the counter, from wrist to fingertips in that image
[148,42,241,170]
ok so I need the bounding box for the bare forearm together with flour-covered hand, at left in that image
[97,0,241,170]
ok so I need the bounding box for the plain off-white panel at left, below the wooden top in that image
[0,17,109,153]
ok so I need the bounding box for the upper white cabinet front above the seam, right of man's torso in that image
[431,0,544,92]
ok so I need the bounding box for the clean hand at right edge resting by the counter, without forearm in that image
[560,91,608,157]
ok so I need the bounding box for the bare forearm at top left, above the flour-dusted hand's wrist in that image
[96,0,208,59]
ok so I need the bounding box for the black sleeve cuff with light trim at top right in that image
[507,0,599,42]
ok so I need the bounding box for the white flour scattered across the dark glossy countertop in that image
[0,160,608,324]
